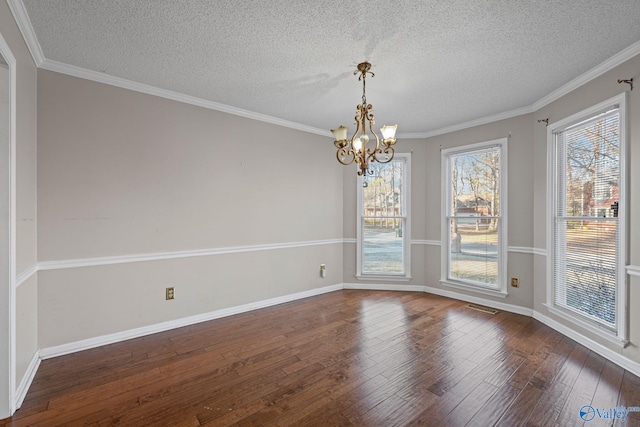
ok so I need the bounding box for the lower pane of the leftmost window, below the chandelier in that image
[362,218,404,274]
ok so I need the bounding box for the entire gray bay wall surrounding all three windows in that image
[344,56,640,363]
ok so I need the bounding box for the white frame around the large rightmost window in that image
[545,92,629,347]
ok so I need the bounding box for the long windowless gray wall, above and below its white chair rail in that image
[38,70,343,348]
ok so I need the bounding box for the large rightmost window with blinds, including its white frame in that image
[548,96,626,342]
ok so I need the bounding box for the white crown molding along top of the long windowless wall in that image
[39,59,331,137]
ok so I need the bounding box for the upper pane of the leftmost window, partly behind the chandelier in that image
[362,161,404,217]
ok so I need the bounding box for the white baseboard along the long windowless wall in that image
[40,284,343,359]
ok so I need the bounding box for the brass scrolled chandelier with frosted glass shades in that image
[331,62,398,175]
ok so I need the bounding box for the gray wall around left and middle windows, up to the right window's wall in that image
[344,114,534,308]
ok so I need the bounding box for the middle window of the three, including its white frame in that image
[442,139,507,296]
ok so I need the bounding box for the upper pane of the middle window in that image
[450,147,500,216]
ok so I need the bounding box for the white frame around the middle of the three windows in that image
[440,138,509,298]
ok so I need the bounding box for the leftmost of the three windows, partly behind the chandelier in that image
[357,154,411,280]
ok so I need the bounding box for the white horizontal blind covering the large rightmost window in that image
[553,108,620,328]
